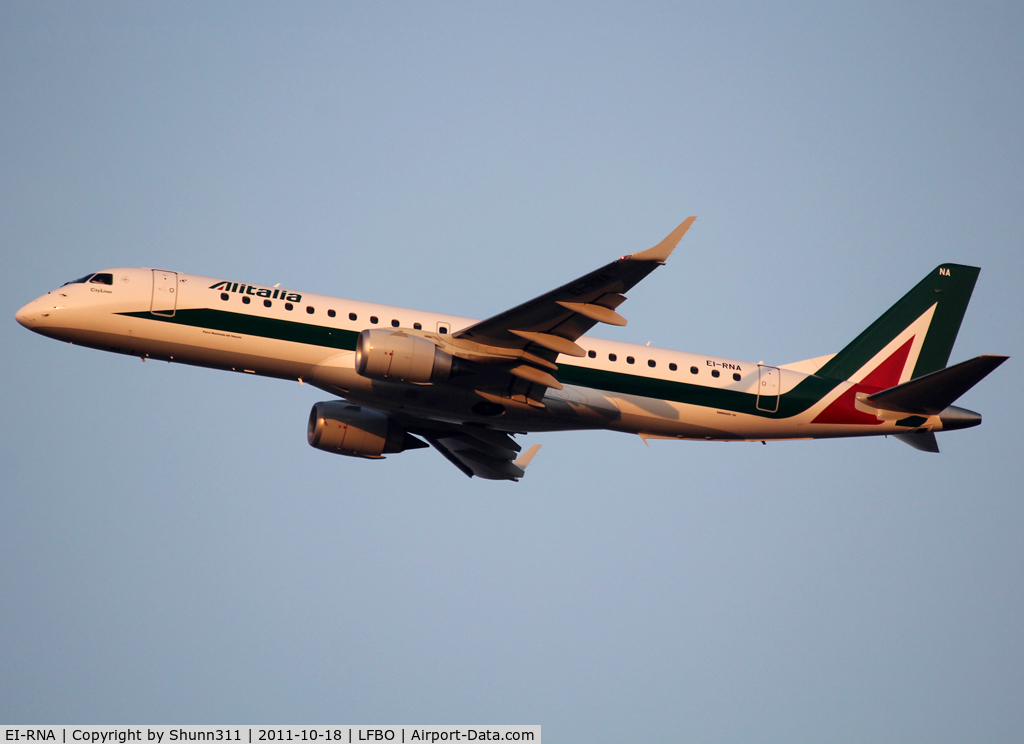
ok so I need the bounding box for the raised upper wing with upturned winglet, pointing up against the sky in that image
[452,217,696,405]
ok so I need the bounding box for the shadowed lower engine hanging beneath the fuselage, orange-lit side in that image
[306,400,428,459]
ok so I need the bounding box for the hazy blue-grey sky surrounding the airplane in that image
[0,1,1024,744]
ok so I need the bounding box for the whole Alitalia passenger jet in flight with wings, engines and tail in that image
[15,217,1008,481]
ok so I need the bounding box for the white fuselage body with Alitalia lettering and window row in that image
[17,268,954,440]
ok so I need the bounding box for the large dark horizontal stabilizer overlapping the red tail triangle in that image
[864,354,1010,415]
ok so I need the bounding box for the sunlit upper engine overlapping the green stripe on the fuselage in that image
[355,329,452,383]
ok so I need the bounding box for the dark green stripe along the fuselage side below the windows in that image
[119,308,840,419]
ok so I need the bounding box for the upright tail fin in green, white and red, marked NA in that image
[816,263,981,388]
